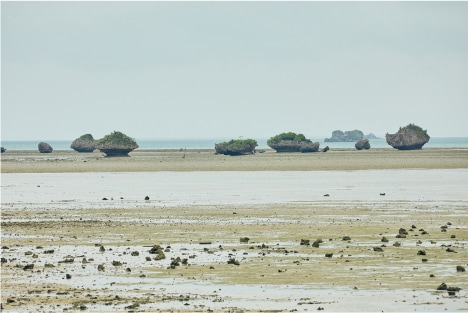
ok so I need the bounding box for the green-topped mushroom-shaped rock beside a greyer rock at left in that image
[96,131,138,157]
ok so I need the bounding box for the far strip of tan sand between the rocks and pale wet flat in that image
[1,148,468,173]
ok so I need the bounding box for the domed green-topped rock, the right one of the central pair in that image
[267,132,320,152]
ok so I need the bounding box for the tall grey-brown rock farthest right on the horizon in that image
[385,124,431,150]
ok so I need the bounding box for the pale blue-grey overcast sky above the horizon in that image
[1,1,468,140]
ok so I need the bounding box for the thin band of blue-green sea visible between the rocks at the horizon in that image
[1,137,468,150]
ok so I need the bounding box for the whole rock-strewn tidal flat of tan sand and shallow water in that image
[1,149,468,312]
